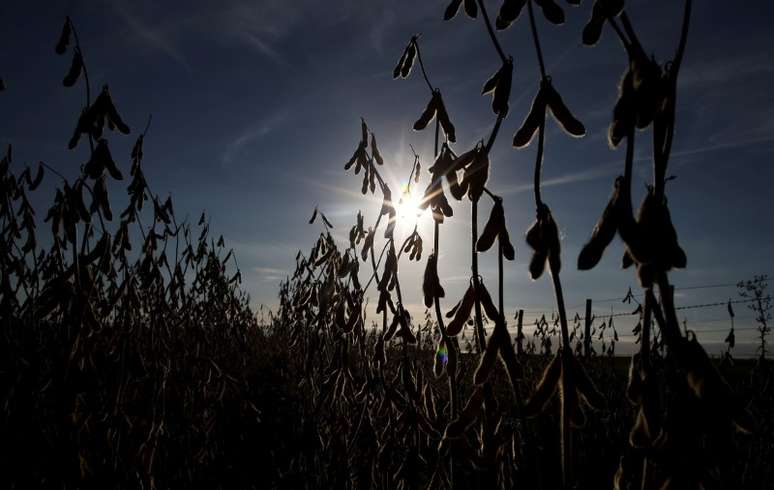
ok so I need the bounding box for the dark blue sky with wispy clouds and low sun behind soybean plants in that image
[0,0,774,352]
